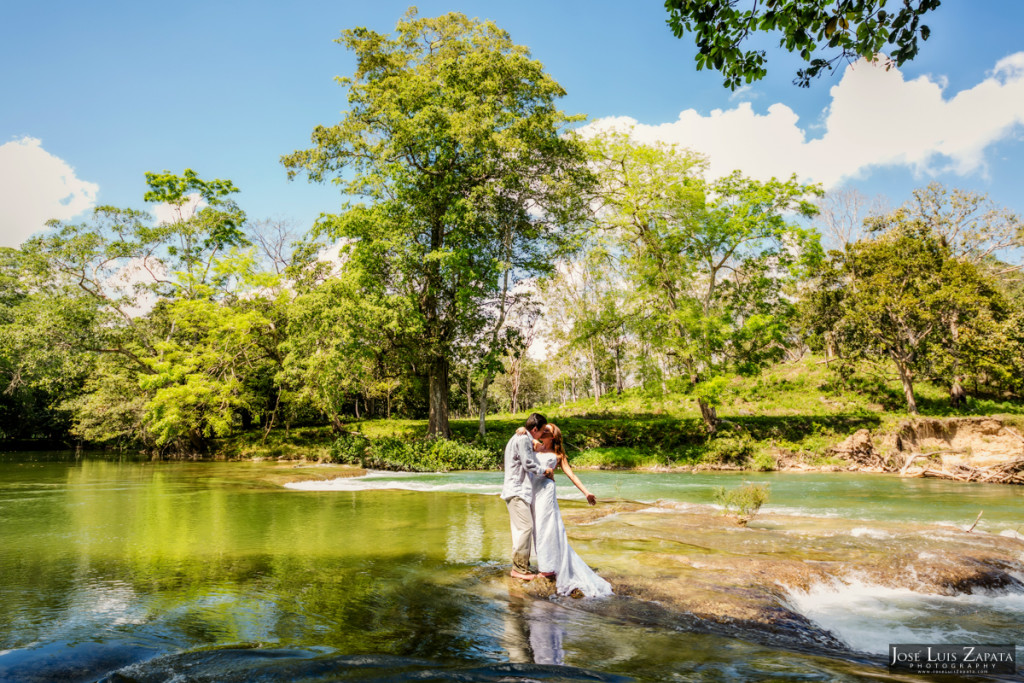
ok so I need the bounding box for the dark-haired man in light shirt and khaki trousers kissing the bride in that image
[502,413,554,581]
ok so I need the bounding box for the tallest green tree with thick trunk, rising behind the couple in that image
[283,10,588,436]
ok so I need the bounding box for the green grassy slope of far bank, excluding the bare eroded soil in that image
[220,357,1024,471]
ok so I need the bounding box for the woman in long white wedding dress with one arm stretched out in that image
[534,423,611,598]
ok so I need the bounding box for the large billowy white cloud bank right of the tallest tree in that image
[582,52,1024,188]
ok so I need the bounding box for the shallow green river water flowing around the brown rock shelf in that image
[0,454,1024,681]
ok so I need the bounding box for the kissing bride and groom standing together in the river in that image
[502,413,611,597]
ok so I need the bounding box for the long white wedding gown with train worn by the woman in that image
[534,453,611,598]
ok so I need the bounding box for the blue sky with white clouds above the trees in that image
[0,0,1024,247]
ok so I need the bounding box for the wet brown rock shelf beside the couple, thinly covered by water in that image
[506,503,1024,656]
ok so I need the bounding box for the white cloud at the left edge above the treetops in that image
[0,137,99,247]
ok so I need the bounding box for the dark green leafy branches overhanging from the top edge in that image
[665,0,939,90]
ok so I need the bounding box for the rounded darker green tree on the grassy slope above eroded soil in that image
[809,216,1004,414]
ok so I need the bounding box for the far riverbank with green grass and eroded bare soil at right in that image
[209,358,1024,483]
